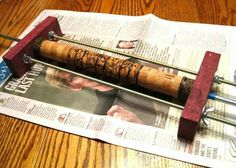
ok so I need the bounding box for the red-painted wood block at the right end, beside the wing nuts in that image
[178,51,220,141]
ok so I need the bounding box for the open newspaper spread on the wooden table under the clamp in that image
[0,10,236,167]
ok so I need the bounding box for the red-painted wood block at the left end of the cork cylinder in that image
[3,16,62,77]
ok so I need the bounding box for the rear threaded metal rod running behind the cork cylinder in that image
[48,31,236,87]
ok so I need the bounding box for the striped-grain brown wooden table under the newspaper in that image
[0,0,236,167]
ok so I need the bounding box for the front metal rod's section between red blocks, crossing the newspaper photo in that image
[24,56,184,110]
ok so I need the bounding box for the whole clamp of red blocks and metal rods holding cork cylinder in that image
[1,17,236,141]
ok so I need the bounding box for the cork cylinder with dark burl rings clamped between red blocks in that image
[34,39,194,100]
